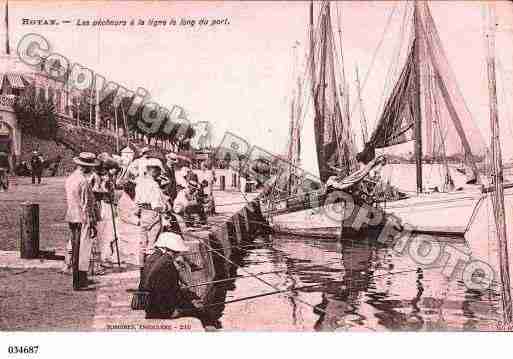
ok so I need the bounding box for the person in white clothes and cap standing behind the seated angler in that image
[135,158,169,265]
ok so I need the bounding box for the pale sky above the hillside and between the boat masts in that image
[2,1,513,174]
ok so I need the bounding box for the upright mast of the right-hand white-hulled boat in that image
[413,0,422,193]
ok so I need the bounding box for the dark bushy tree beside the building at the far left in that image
[14,86,58,140]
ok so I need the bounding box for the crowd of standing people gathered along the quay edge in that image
[64,147,216,296]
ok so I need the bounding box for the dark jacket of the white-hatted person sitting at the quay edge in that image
[139,249,180,319]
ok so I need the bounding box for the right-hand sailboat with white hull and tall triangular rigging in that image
[361,1,511,237]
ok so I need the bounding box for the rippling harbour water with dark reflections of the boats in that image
[203,233,501,331]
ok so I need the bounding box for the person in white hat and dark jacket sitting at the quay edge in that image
[139,232,189,319]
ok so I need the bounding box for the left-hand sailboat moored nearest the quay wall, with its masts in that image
[266,1,388,238]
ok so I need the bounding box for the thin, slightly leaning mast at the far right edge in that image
[486,2,513,327]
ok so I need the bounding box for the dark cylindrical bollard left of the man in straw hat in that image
[19,202,39,259]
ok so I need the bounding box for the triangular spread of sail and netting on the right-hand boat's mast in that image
[358,1,486,181]
